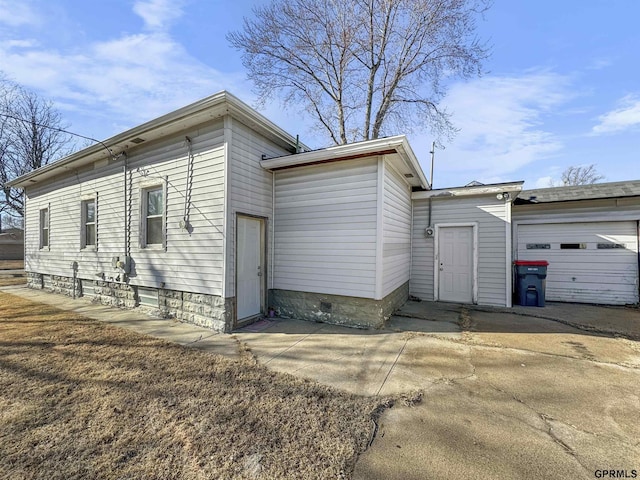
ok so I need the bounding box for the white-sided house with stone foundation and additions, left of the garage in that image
[11,92,637,332]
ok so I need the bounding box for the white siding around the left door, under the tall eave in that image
[225,118,290,297]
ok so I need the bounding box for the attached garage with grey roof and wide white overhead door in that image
[513,181,640,305]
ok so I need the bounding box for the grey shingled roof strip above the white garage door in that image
[515,180,640,205]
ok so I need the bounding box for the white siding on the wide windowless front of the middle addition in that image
[273,158,378,298]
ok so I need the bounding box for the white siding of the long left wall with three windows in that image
[26,121,225,295]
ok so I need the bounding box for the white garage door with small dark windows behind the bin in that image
[517,222,638,305]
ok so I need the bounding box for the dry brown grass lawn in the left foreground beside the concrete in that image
[0,292,389,479]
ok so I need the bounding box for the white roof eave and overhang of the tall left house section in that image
[8,91,308,187]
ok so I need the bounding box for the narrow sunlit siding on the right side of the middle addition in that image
[382,164,411,297]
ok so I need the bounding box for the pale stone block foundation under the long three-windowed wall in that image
[27,272,235,333]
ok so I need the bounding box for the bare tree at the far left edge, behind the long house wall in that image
[0,77,71,217]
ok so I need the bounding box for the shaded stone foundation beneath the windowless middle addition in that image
[269,282,409,328]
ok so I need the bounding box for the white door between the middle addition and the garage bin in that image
[437,227,473,303]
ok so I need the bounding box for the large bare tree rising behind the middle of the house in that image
[227,0,490,144]
